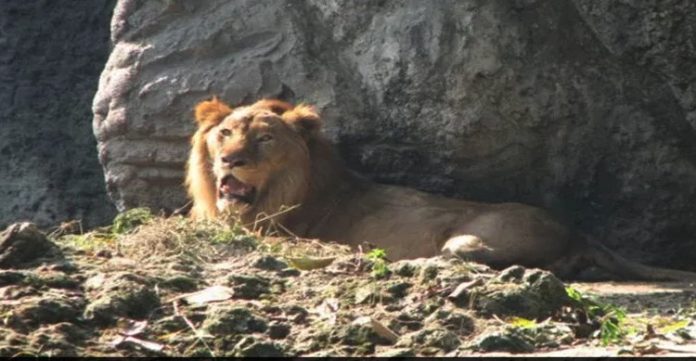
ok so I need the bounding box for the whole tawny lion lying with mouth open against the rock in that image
[186,97,696,281]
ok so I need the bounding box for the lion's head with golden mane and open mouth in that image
[187,98,321,223]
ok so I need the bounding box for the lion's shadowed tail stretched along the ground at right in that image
[586,239,696,282]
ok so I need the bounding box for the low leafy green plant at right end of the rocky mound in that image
[566,287,627,346]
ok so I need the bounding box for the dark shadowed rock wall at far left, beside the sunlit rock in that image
[0,0,115,228]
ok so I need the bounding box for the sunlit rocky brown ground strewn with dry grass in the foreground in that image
[0,209,696,357]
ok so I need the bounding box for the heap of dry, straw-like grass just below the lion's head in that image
[57,208,353,263]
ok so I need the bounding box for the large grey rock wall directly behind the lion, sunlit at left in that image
[93,0,696,269]
